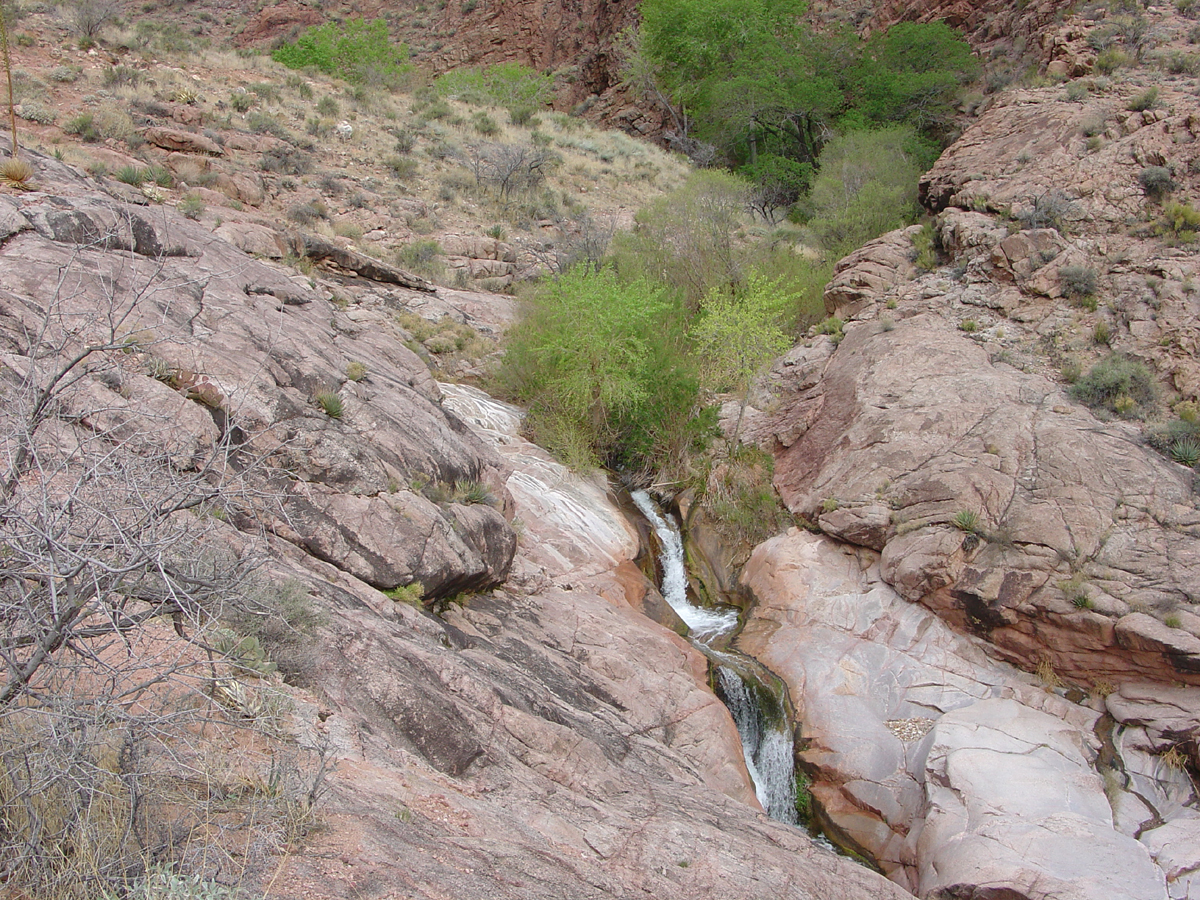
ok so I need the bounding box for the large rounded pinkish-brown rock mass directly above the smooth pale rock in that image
[775,314,1200,684]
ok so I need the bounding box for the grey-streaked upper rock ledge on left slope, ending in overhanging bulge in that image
[0,151,516,607]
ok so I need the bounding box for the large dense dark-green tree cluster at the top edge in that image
[641,0,978,164]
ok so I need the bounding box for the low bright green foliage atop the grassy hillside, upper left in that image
[271,18,413,88]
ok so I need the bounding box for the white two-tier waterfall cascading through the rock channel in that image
[631,491,797,824]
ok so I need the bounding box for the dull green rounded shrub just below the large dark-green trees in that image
[809,127,922,254]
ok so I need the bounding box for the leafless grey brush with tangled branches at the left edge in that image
[0,237,324,900]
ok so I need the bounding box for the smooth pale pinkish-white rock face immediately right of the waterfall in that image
[738,529,1200,900]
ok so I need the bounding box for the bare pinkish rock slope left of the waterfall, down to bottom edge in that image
[0,139,902,898]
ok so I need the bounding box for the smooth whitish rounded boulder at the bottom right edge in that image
[918,698,1168,900]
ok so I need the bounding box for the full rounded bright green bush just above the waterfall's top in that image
[497,269,697,468]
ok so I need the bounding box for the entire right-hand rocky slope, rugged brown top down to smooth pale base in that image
[720,7,1200,898]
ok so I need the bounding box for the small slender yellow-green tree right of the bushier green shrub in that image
[691,274,797,449]
